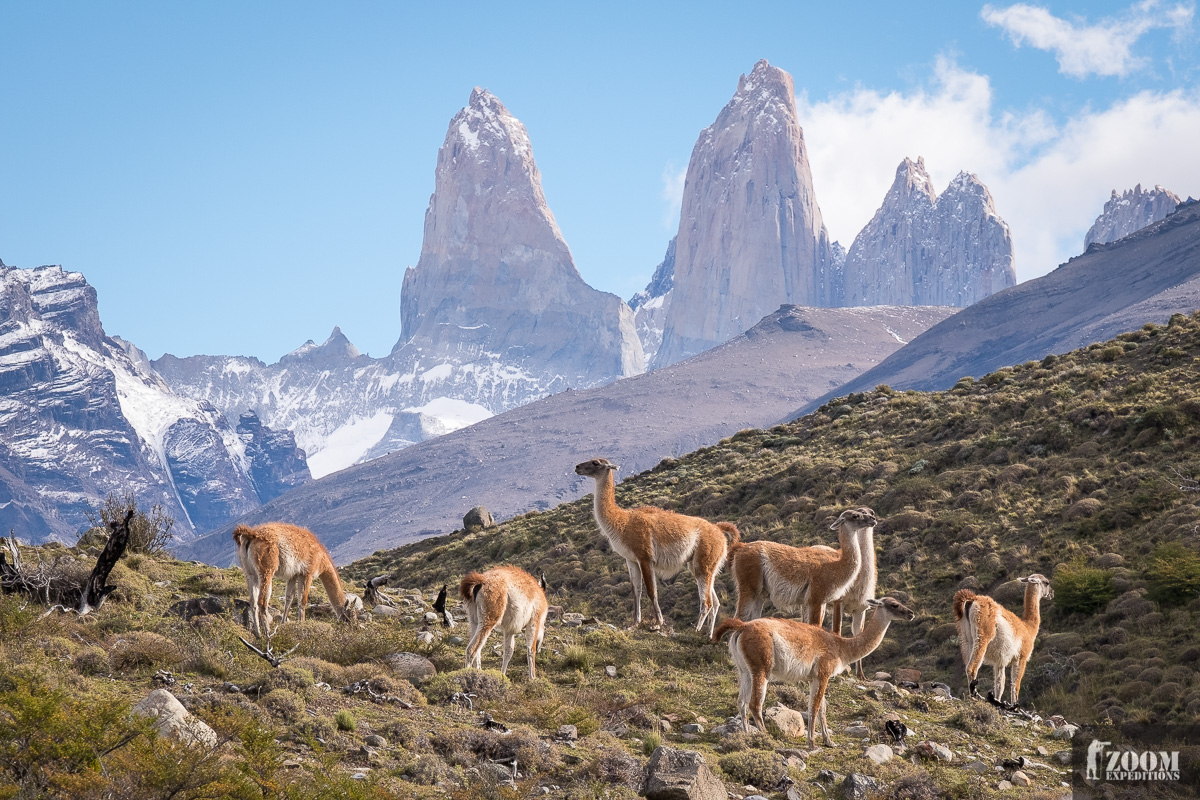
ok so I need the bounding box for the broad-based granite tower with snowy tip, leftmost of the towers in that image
[394,89,644,389]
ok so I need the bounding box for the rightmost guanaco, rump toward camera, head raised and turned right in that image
[954,573,1054,705]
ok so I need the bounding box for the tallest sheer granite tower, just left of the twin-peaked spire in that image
[653,61,841,367]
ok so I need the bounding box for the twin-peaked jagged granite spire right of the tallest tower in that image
[844,158,1016,307]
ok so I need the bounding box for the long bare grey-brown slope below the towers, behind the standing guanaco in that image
[182,307,950,564]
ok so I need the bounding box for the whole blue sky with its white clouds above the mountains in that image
[0,1,1200,361]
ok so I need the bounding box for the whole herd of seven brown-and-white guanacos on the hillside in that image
[233,458,1054,750]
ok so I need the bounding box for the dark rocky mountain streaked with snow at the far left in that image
[0,263,307,541]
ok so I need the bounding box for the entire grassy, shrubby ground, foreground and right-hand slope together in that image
[0,315,1200,799]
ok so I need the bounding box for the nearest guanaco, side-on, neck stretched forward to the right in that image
[713,597,916,750]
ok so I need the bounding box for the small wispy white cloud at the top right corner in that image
[980,0,1194,78]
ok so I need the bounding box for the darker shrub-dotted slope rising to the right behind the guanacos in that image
[343,313,1200,734]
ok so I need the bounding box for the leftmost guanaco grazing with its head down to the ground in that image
[233,522,350,636]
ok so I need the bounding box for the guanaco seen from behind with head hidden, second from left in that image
[458,566,548,680]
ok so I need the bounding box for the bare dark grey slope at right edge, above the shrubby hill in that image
[791,204,1200,419]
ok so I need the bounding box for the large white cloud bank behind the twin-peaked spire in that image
[797,59,1200,281]
